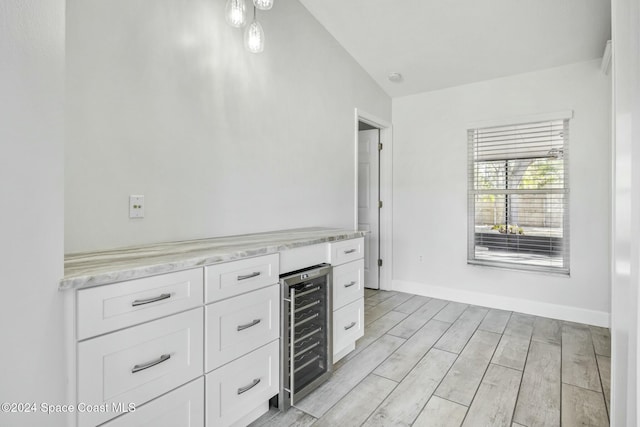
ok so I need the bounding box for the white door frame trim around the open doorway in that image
[353,108,393,290]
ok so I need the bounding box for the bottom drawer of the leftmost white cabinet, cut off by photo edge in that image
[101,377,204,427]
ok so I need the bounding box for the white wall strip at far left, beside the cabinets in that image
[0,0,66,426]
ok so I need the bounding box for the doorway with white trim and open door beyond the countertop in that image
[354,109,391,290]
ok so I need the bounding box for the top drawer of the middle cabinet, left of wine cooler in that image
[205,254,280,303]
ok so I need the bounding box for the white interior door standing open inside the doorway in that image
[358,129,380,289]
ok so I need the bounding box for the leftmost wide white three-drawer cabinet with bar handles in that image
[73,268,205,427]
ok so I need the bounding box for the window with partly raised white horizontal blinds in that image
[468,120,569,274]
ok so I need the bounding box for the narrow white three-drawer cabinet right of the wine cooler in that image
[329,238,365,363]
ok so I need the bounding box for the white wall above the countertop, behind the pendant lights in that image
[65,0,391,252]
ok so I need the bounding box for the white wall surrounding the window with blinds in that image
[393,61,611,324]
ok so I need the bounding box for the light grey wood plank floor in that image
[251,289,611,427]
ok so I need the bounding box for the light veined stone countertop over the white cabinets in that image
[58,228,366,290]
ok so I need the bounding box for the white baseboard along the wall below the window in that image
[391,280,611,328]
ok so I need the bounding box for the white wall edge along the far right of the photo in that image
[611,0,640,426]
